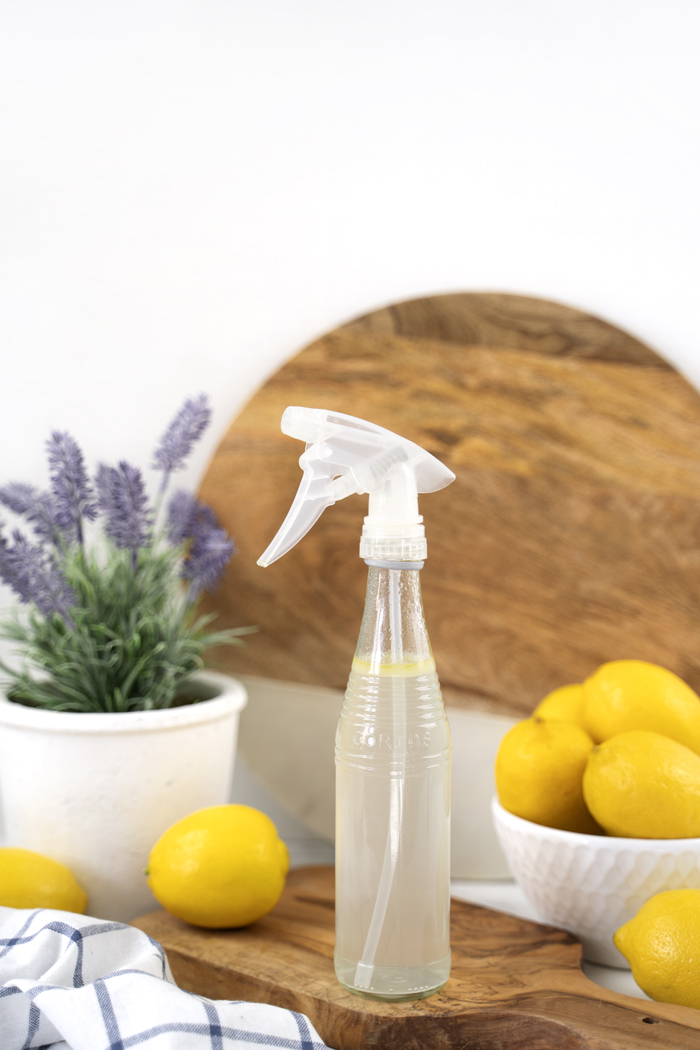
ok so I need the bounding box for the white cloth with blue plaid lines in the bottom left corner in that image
[0,907,325,1050]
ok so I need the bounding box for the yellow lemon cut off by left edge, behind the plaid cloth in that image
[0,846,87,915]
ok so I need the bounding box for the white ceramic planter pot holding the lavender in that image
[0,671,248,922]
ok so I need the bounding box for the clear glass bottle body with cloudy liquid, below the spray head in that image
[335,566,451,1001]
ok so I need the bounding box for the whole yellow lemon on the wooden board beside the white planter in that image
[147,805,290,928]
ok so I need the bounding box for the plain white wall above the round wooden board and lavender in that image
[0,0,700,501]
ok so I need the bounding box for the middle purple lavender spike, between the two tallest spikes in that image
[94,460,151,554]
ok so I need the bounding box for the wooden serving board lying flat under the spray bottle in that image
[133,867,700,1050]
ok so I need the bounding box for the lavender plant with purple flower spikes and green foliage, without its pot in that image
[0,396,251,711]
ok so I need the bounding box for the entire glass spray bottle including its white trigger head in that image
[258,407,454,1002]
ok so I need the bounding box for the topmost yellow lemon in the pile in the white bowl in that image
[584,659,700,755]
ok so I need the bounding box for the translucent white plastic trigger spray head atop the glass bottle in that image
[258,407,454,566]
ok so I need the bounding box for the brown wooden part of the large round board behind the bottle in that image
[201,293,700,715]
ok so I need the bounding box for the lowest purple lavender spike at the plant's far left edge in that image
[0,529,76,623]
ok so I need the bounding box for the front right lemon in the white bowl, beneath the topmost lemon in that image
[584,730,700,839]
